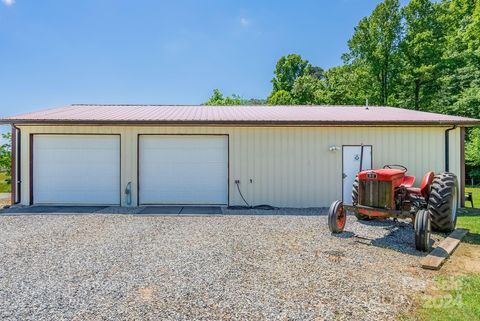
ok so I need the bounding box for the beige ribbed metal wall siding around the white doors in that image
[16,126,460,207]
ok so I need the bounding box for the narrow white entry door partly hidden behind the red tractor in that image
[342,145,372,204]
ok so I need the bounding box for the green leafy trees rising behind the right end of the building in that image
[205,0,480,178]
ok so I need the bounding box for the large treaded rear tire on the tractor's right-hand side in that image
[428,173,458,232]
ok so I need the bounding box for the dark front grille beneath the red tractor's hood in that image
[359,180,392,208]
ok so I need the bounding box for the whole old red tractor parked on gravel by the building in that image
[328,165,458,251]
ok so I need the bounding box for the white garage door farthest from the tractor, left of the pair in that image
[33,135,120,205]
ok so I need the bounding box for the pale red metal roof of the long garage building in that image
[0,104,480,125]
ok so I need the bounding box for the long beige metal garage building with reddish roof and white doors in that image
[1,105,480,207]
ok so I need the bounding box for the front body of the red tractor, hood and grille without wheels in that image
[358,169,407,210]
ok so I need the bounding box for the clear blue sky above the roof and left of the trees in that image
[0,0,408,129]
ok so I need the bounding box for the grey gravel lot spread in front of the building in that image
[0,211,438,320]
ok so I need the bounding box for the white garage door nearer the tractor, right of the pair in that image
[139,135,228,205]
